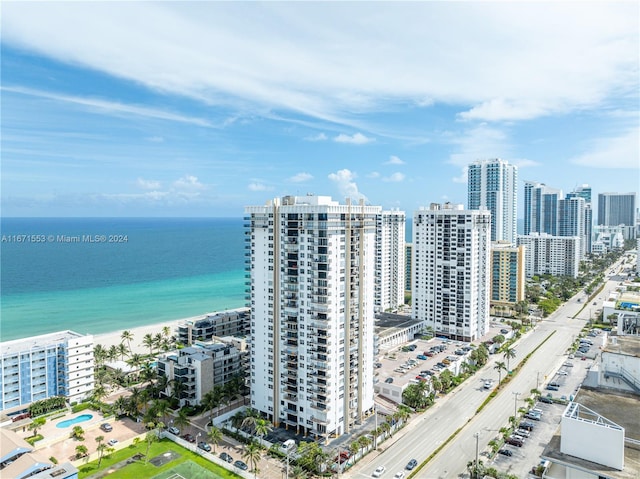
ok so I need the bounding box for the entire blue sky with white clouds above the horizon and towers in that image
[0,0,640,217]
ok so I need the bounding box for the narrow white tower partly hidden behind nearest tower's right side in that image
[375,210,407,312]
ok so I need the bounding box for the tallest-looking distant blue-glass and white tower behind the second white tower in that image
[467,159,518,244]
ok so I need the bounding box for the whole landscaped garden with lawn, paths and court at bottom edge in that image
[79,439,240,479]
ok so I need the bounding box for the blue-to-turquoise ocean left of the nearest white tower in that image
[0,218,245,341]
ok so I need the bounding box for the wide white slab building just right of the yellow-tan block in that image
[518,233,581,278]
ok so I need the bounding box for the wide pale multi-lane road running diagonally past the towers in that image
[345,258,618,478]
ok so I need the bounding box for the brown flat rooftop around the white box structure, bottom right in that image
[541,389,640,479]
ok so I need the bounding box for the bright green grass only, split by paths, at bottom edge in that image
[78,439,240,479]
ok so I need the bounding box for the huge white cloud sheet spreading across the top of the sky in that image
[3,2,638,124]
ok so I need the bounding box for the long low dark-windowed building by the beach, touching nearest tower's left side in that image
[176,308,250,345]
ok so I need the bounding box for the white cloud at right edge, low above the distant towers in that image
[570,128,640,170]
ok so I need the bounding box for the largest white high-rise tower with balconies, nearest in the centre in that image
[245,195,382,439]
